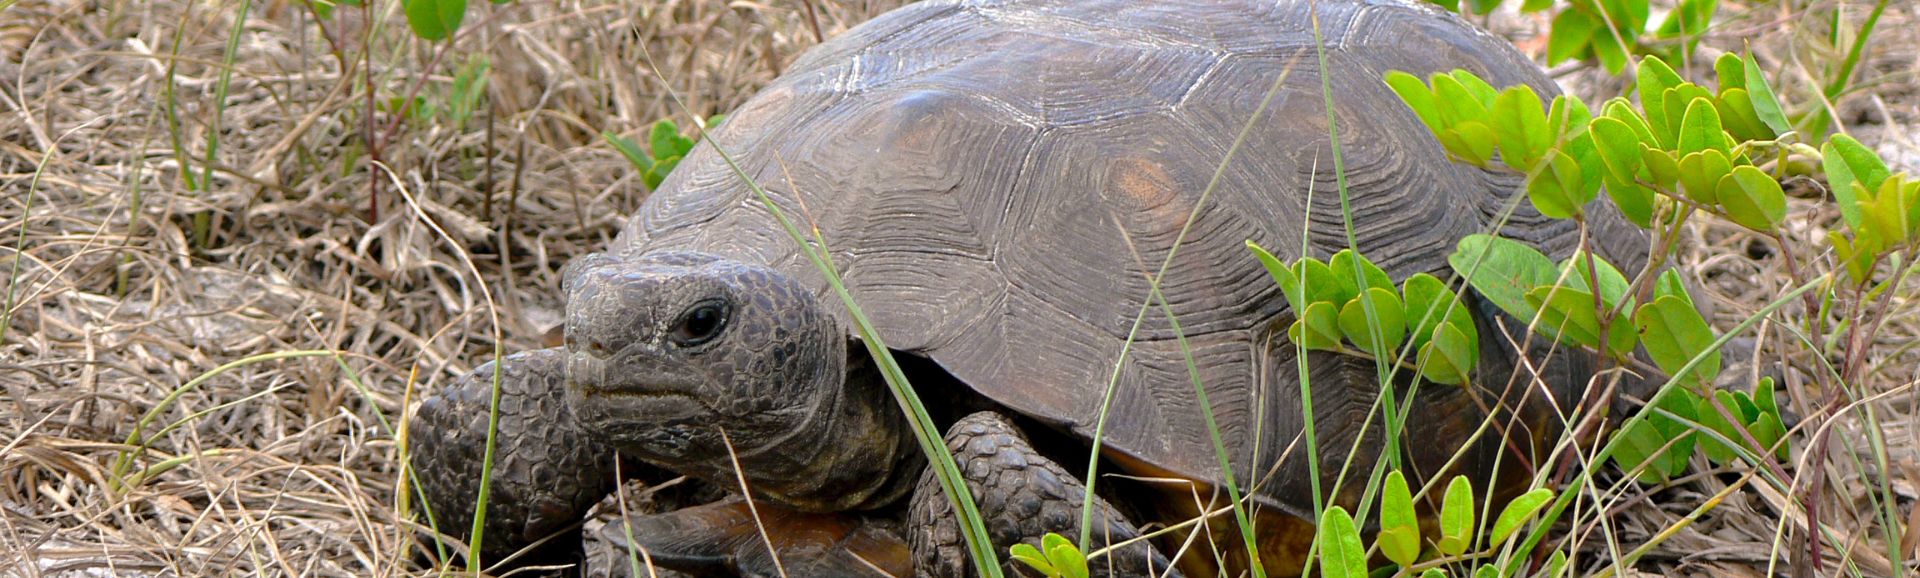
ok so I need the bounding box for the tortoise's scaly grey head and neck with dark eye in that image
[564,252,918,511]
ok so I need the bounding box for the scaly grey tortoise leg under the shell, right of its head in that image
[906,411,1183,578]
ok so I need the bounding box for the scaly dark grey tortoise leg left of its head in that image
[407,348,616,565]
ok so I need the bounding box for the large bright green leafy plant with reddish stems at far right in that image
[1386,54,1920,572]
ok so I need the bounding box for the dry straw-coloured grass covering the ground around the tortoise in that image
[0,0,1920,576]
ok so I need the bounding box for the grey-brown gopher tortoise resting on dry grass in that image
[411,0,1644,576]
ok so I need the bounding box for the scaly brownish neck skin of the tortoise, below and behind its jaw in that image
[687,349,925,511]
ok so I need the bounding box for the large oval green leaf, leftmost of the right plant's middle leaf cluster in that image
[1446,234,1559,319]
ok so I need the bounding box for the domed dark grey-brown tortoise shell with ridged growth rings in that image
[616,0,1628,518]
